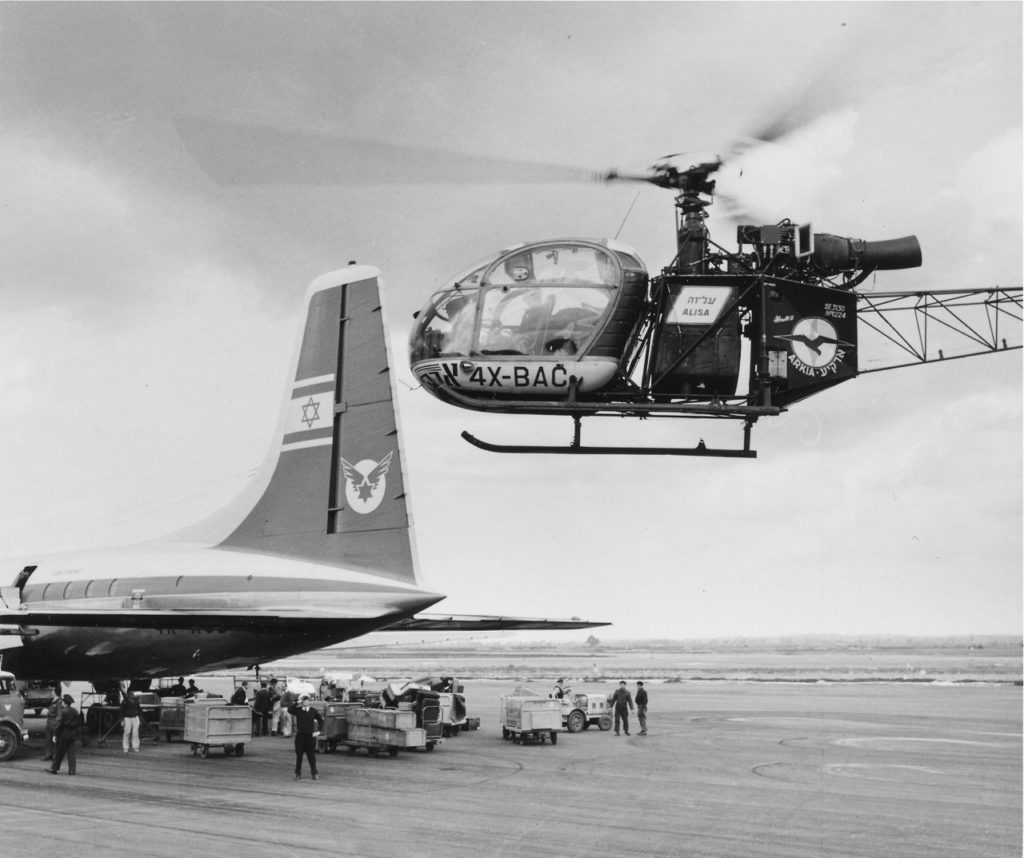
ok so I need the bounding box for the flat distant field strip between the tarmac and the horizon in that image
[263,638,1022,684]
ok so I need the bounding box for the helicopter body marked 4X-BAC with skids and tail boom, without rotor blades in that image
[410,160,1021,458]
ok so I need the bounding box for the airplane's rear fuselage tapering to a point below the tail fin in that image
[0,545,441,680]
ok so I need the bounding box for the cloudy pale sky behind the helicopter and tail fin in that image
[0,2,1024,638]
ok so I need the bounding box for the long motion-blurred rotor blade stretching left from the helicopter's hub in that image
[174,116,598,185]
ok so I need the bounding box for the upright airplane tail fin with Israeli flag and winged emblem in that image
[209,265,419,584]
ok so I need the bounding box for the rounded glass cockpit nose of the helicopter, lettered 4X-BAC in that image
[410,239,647,404]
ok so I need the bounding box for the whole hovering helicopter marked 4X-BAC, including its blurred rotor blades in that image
[175,116,1024,459]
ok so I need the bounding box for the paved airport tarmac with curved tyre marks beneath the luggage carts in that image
[0,681,1022,858]
